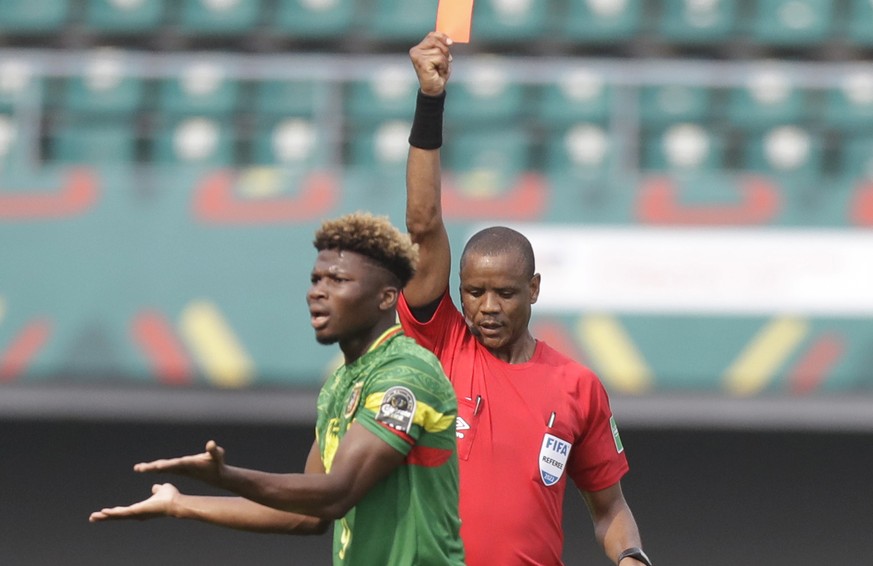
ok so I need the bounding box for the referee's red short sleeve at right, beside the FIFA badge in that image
[569,370,628,491]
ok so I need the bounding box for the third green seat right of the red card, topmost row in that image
[658,0,738,44]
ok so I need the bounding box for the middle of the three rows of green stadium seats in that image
[0,49,873,134]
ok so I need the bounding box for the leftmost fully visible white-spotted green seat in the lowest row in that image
[149,115,236,167]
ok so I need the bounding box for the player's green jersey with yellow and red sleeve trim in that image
[316,326,464,566]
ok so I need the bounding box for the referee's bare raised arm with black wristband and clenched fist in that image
[403,32,451,307]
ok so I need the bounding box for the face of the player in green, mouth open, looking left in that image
[306,250,383,344]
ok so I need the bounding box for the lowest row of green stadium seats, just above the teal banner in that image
[0,106,873,184]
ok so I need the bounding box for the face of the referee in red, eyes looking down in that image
[460,253,540,352]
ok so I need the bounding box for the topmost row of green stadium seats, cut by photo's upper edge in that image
[0,0,873,47]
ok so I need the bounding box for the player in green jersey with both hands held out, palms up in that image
[90,213,464,566]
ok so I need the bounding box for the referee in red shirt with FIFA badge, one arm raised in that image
[398,32,649,566]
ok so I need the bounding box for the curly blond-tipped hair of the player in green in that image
[312,212,418,287]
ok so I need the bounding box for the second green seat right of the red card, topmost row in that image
[557,0,643,44]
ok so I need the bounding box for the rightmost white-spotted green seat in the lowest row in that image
[743,125,822,182]
